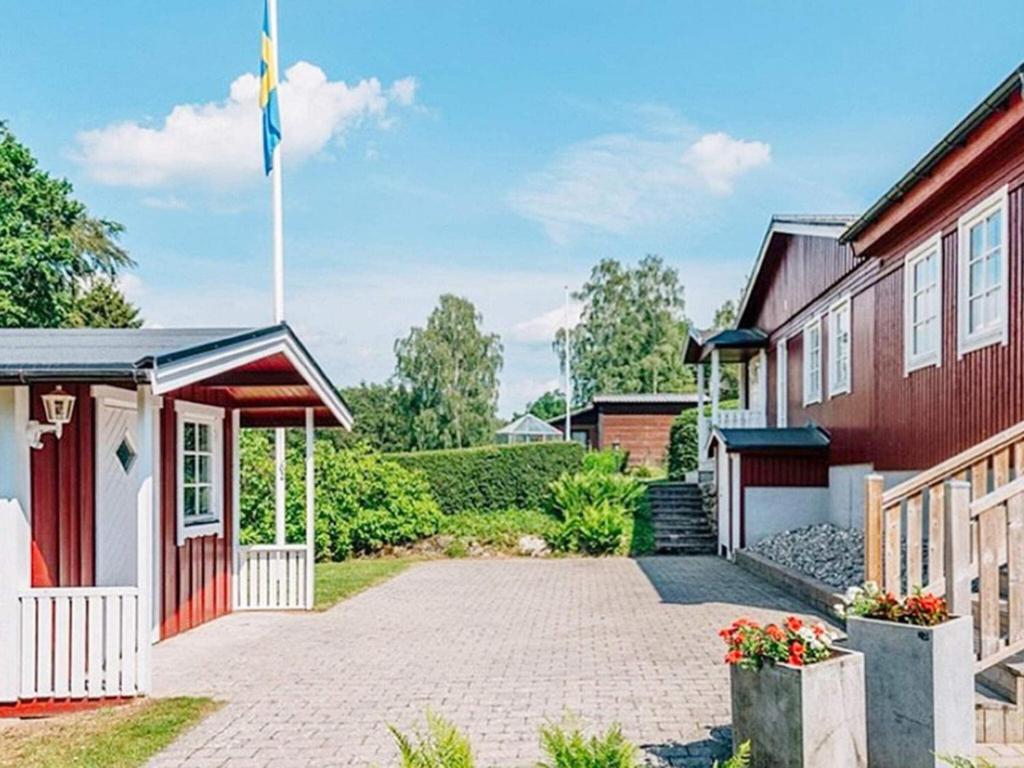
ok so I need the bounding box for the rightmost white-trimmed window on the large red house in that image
[956,187,1009,355]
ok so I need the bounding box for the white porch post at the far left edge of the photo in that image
[0,386,32,702]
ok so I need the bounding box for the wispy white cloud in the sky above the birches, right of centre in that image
[510,120,771,243]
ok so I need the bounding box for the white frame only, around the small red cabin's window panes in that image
[174,400,224,547]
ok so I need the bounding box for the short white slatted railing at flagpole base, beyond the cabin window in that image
[234,544,312,610]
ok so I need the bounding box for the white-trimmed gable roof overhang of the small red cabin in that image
[146,323,353,429]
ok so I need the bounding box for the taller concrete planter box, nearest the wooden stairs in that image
[846,616,975,768]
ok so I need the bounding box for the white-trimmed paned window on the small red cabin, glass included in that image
[174,400,224,544]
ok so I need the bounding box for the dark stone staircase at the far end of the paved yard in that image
[647,482,718,555]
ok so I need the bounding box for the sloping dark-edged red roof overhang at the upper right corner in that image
[840,65,1024,256]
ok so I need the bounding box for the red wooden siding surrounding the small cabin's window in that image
[160,388,232,638]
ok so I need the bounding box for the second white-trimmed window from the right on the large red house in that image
[903,232,942,374]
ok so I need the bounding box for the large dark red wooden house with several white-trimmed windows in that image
[685,66,1024,553]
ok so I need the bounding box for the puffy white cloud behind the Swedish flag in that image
[74,61,417,187]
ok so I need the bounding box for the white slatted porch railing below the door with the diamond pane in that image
[18,587,141,698]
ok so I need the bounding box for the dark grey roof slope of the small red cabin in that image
[0,327,256,379]
